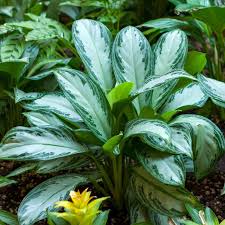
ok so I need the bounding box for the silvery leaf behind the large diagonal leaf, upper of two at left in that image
[19,92,82,126]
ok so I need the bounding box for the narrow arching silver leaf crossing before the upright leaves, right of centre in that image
[132,70,196,96]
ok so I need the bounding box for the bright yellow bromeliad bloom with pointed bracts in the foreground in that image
[54,189,108,225]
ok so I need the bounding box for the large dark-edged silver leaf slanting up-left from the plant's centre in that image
[55,68,112,142]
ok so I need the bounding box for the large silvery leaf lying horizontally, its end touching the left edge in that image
[0,127,88,160]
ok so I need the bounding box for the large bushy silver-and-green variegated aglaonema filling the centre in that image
[0,19,225,225]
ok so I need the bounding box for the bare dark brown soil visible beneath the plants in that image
[0,159,225,225]
